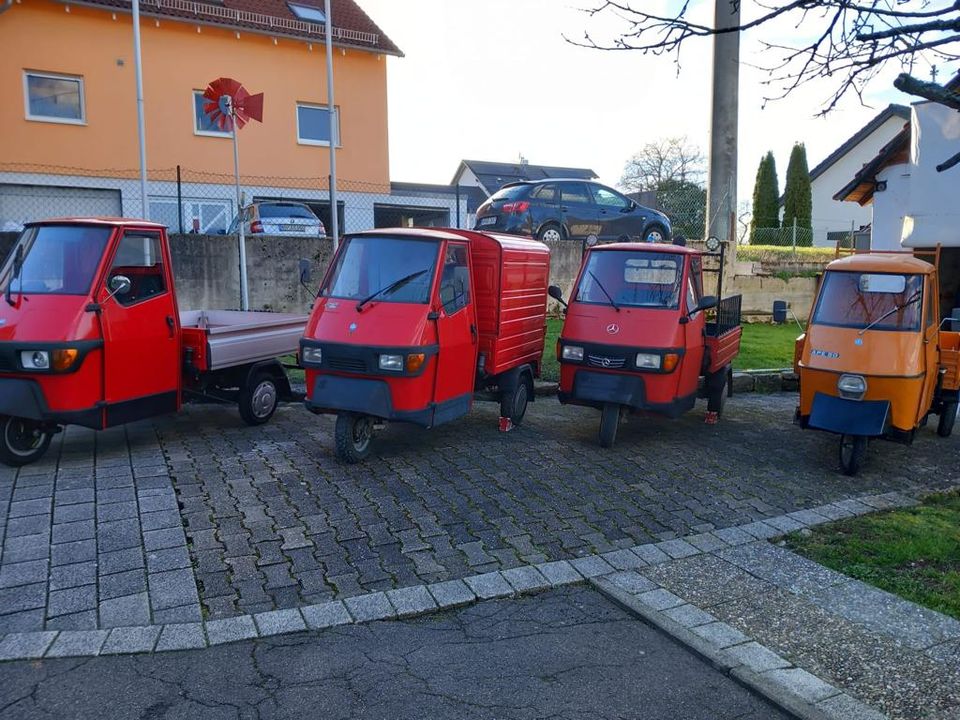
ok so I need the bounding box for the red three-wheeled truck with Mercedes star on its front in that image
[550,243,740,447]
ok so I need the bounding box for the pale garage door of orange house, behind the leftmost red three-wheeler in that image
[0,184,123,231]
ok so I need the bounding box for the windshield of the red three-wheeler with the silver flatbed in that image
[0,225,112,295]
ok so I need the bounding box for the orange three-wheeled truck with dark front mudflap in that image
[794,253,960,475]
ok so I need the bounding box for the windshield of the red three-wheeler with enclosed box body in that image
[320,237,440,304]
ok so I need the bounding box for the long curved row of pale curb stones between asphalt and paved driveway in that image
[0,492,918,676]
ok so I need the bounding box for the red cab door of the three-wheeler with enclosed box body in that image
[433,242,479,425]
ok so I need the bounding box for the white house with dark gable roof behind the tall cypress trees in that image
[810,105,910,246]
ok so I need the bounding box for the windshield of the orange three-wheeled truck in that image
[813,270,923,330]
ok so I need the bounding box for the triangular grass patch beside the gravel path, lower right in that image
[787,492,960,619]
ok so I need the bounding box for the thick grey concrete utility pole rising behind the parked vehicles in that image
[706,0,740,242]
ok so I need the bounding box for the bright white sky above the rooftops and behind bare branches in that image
[350,0,952,200]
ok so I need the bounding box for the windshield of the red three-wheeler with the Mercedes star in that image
[573,250,683,310]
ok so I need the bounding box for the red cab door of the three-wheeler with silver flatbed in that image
[97,228,180,427]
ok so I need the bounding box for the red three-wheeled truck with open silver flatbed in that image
[0,218,306,466]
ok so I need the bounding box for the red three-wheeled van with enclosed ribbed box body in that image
[300,228,550,462]
